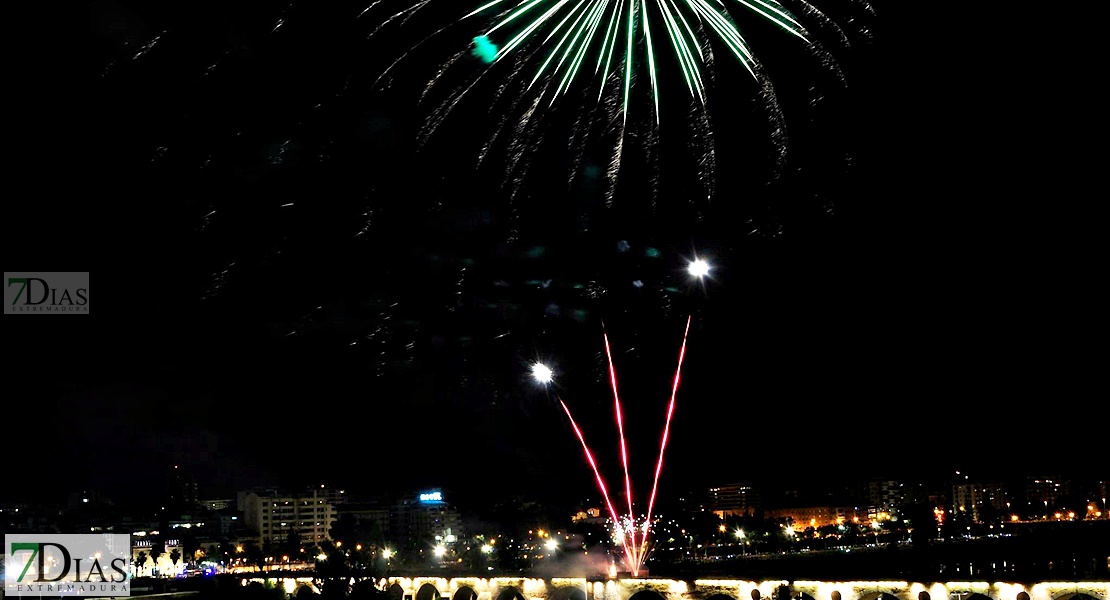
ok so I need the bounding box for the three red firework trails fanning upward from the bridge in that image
[548,317,692,577]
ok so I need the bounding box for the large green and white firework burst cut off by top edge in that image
[364,0,874,212]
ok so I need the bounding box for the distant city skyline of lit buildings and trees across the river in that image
[0,467,1108,527]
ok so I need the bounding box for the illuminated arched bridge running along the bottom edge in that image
[247,577,1110,600]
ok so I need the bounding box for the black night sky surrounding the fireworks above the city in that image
[0,1,1106,507]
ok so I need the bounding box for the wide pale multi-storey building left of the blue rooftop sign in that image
[245,489,335,543]
